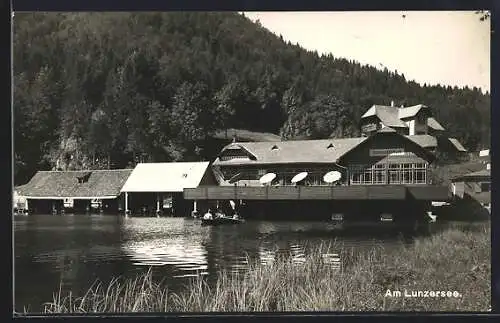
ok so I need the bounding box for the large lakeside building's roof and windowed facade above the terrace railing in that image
[213,128,434,186]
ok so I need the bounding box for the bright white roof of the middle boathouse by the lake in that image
[121,162,209,192]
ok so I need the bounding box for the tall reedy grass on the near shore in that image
[38,226,491,313]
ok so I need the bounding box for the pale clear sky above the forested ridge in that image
[245,11,491,92]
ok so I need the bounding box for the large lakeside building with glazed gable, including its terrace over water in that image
[184,127,451,223]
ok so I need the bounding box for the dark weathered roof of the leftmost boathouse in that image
[18,169,132,198]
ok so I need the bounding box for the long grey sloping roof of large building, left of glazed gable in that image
[214,137,367,165]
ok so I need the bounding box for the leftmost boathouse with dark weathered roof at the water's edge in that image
[17,169,132,213]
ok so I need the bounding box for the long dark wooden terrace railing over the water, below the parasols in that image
[184,185,451,201]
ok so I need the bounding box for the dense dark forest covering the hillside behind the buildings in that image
[13,12,490,184]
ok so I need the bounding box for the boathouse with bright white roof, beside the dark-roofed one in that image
[121,162,217,216]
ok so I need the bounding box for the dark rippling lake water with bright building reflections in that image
[14,215,468,312]
